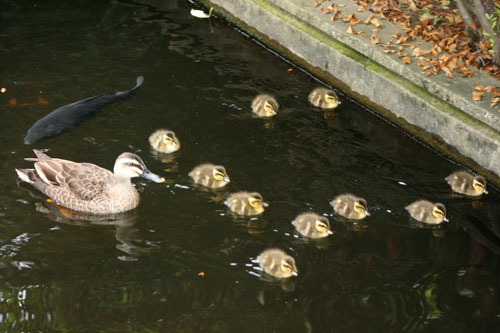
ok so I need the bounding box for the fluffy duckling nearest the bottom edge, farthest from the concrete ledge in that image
[257,249,299,278]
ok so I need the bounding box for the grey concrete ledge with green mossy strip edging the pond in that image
[197,0,500,179]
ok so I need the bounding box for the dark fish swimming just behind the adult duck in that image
[24,76,144,144]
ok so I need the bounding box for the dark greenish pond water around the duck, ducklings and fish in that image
[0,0,500,332]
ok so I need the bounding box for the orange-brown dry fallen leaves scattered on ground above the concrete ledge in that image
[315,0,500,107]
